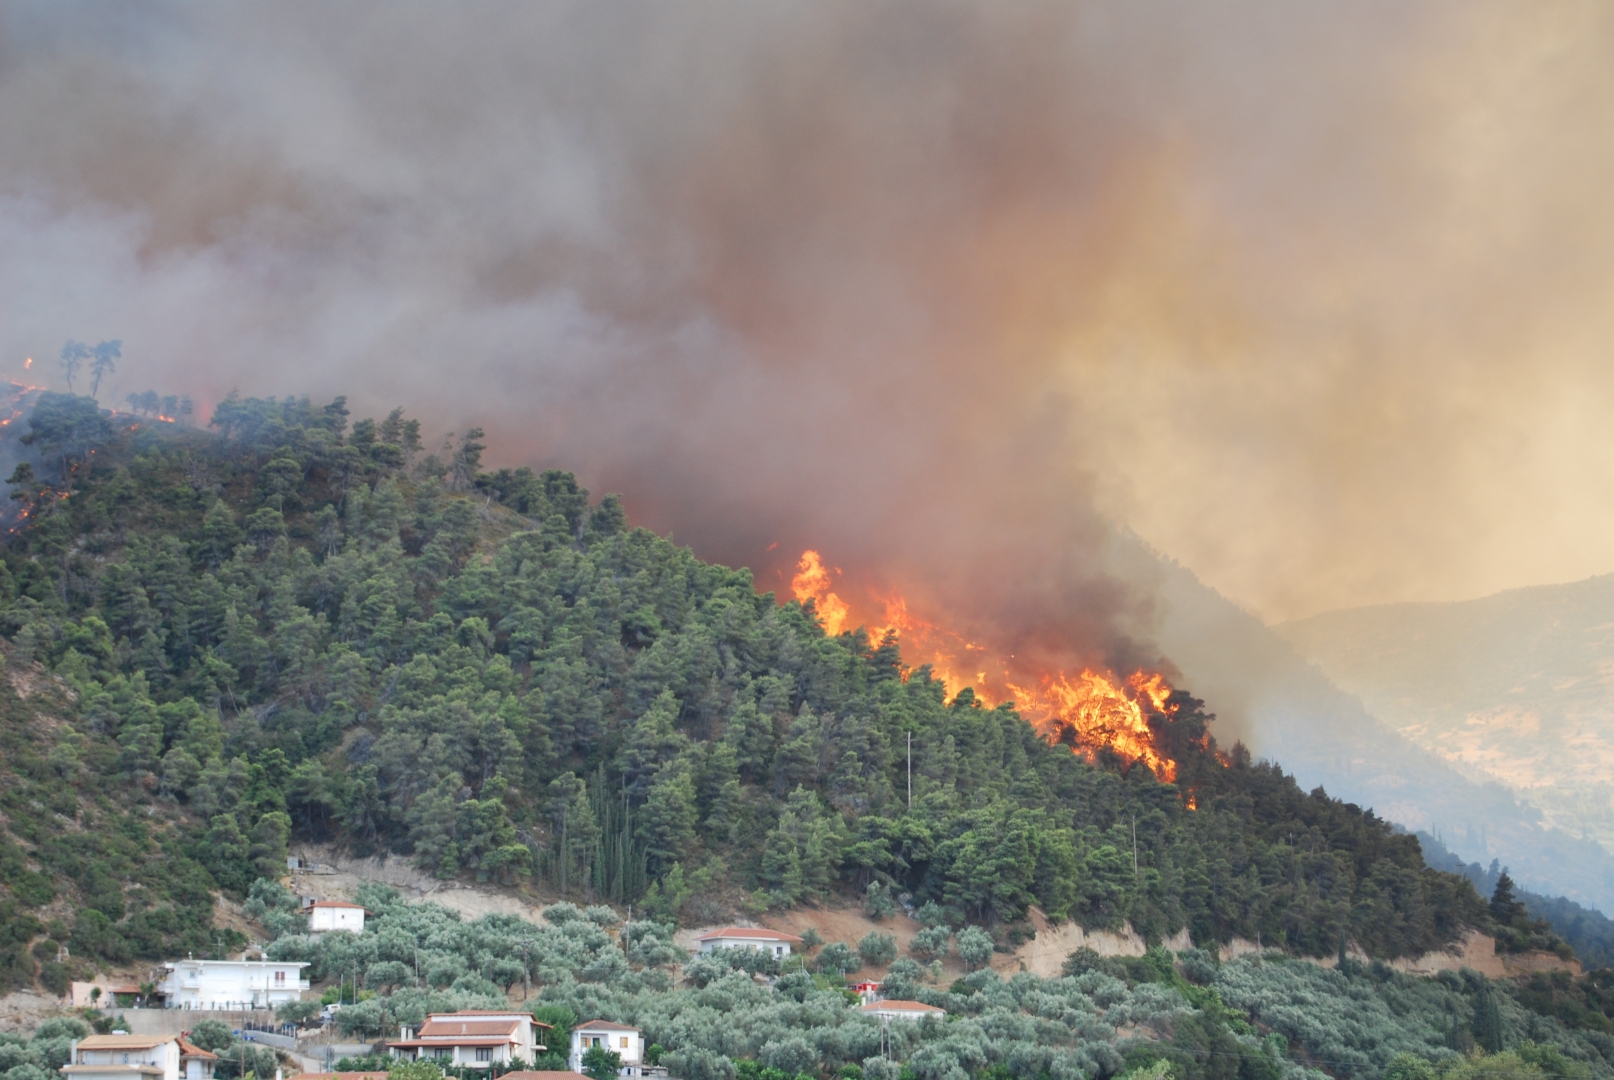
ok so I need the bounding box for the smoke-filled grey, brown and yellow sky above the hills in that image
[0,0,1614,634]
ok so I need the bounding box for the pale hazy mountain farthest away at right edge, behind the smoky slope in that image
[1273,575,1614,849]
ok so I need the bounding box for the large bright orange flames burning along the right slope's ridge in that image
[791,550,1207,781]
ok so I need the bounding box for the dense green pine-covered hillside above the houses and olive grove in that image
[0,394,1490,987]
